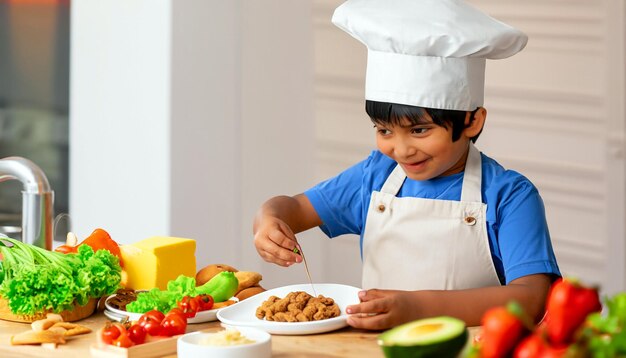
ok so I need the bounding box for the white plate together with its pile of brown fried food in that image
[217,283,361,335]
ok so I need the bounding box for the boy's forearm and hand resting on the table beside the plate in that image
[347,274,551,329]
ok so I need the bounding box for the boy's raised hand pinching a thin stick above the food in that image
[254,216,302,267]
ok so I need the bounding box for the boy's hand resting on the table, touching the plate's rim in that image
[346,289,417,330]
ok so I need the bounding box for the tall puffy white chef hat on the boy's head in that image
[332,0,528,111]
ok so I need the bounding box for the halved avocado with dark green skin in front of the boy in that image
[378,316,467,358]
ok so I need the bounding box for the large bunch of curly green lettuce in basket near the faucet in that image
[0,237,122,315]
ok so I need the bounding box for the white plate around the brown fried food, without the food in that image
[217,283,361,335]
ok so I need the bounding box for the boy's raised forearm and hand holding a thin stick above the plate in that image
[252,194,322,266]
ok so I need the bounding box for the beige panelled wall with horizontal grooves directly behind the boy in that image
[313,0,626,293]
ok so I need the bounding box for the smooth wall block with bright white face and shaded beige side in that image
[70,0,315,287]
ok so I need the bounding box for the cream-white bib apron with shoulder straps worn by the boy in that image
[363,144,500,290]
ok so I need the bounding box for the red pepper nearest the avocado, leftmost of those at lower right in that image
[479,301,532,358]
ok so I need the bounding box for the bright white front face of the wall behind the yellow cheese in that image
[70,0,172,243]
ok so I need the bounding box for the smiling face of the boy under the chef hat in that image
[375,112,470,180]
